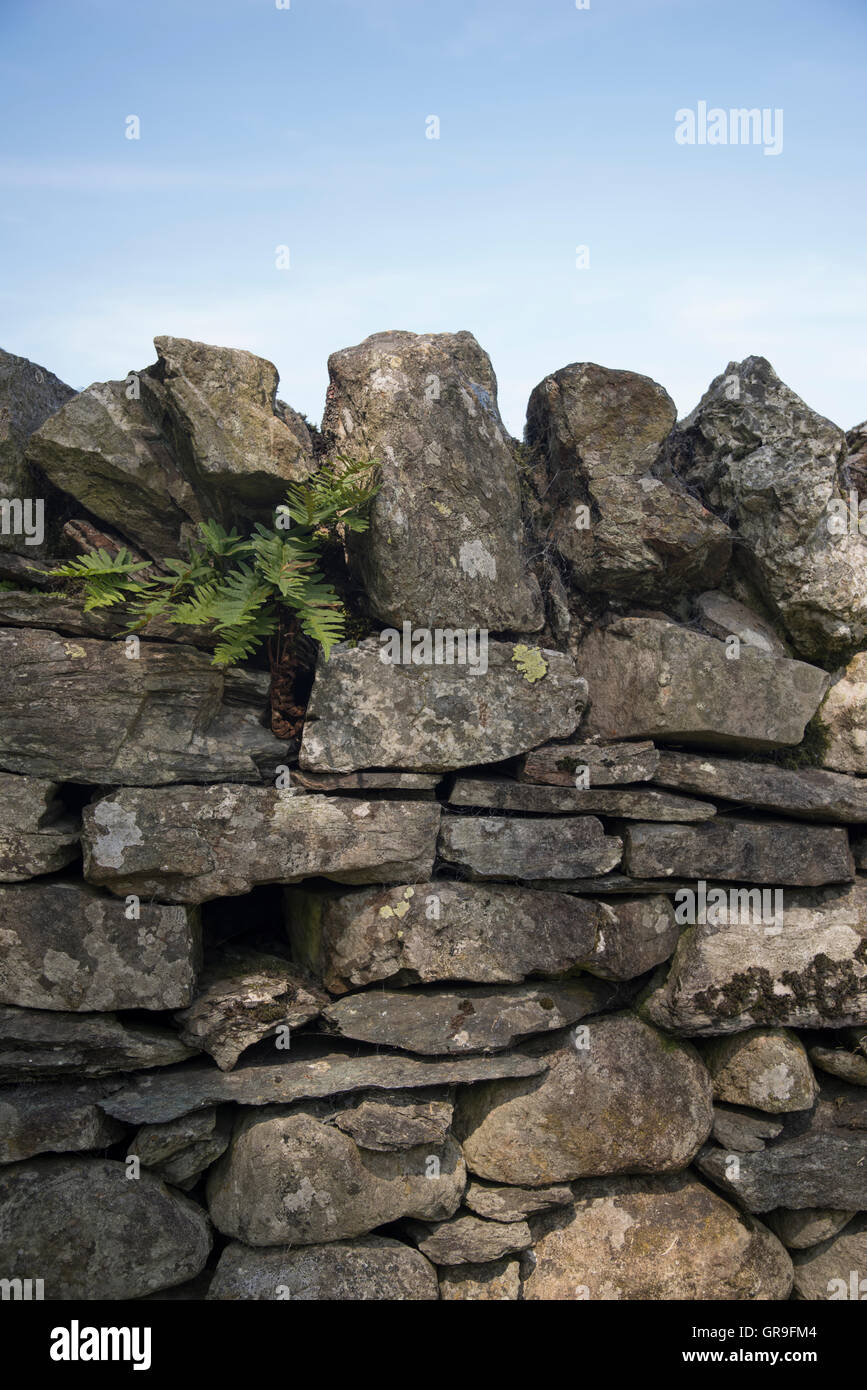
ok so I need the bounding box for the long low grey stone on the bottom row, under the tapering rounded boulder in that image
[207,1236,438,1302]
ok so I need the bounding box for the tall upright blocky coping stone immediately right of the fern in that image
[322,332,543,632]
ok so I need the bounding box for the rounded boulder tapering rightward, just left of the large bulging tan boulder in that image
[207,1106,467,1245]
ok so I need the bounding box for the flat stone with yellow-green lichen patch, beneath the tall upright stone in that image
[300,637,586,773]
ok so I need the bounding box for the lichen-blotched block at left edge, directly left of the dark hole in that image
[0,880,201,1013]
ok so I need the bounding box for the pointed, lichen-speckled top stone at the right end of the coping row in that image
[668,357,867,659]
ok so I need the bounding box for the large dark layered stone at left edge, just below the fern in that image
[0,628,286,787]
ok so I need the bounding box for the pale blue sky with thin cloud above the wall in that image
[0,0,867,434]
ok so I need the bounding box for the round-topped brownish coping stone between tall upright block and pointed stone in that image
[527,363,732,598]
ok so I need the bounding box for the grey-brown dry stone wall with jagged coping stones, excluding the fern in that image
[0,332,867,1301]
